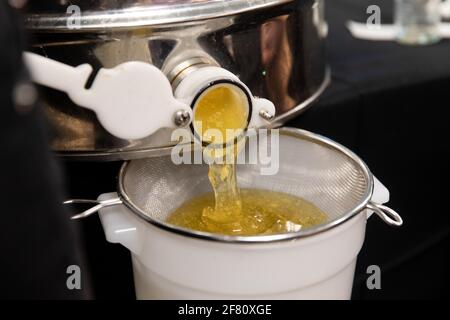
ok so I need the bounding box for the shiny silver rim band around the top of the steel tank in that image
[24,0,298,33]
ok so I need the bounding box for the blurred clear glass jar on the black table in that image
[394,0,441,45]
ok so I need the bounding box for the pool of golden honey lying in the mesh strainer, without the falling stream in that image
[168,189,327,236]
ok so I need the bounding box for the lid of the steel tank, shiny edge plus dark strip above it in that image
[25,0,294,32]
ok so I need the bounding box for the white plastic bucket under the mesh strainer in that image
[99,178,389,299]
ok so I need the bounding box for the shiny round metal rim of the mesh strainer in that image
[118,127,374,244]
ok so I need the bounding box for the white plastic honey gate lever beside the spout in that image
[24,52,192,140]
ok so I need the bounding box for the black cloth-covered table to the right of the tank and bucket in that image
[288,0,450,299]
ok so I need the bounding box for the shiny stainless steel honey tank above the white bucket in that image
[26,0,329,160]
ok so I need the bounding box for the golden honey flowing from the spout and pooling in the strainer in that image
[168,84,327,236]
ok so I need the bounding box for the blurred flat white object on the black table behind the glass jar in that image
[347,21,450,41]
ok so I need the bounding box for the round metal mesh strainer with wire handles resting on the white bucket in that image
[66,128,402,242]
